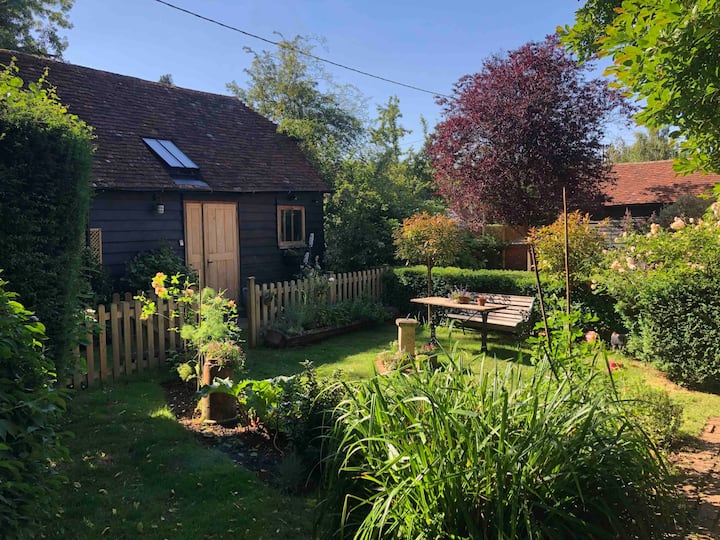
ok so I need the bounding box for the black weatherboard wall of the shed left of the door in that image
[90,191,185,276]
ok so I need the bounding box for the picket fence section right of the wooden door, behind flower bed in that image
[247,267,388,347]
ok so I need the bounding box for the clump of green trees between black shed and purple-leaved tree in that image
[233,36,442,271]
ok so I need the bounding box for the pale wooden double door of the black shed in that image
[185,202,240,300]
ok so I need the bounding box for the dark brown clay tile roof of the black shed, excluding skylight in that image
[0,49,328,192]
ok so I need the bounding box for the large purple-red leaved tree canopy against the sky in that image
[429,36,626,226]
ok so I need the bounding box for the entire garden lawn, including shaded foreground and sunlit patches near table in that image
[47,324,720,539]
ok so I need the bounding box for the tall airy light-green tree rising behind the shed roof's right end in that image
[227,36,365,185]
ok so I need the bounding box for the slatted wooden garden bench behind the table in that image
[446,293,535,334]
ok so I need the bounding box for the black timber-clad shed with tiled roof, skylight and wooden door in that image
[0,49,328,304]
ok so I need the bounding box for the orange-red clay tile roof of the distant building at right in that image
[605,160,720,206]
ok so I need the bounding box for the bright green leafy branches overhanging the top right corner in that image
[561,0,720,172]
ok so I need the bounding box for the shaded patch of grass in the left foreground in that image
[46,374,314,539]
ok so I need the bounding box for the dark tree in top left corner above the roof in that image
[0,0,75,57]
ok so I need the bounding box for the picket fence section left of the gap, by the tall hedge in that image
[72,293,184,388]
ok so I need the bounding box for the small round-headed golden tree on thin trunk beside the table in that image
[395,212,460,320]
